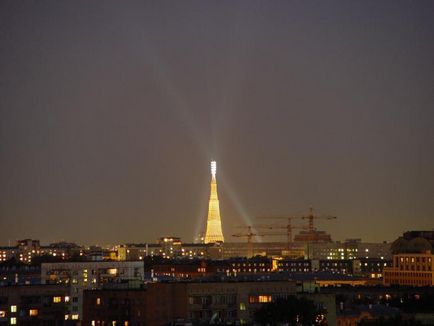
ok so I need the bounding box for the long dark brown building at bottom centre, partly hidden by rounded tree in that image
[82,280,336,325]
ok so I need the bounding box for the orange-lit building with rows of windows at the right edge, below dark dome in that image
[383,252,434,286]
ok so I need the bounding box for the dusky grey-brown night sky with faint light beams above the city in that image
[0,0,434,244]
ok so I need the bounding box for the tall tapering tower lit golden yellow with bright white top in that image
[205,161,225,243]
